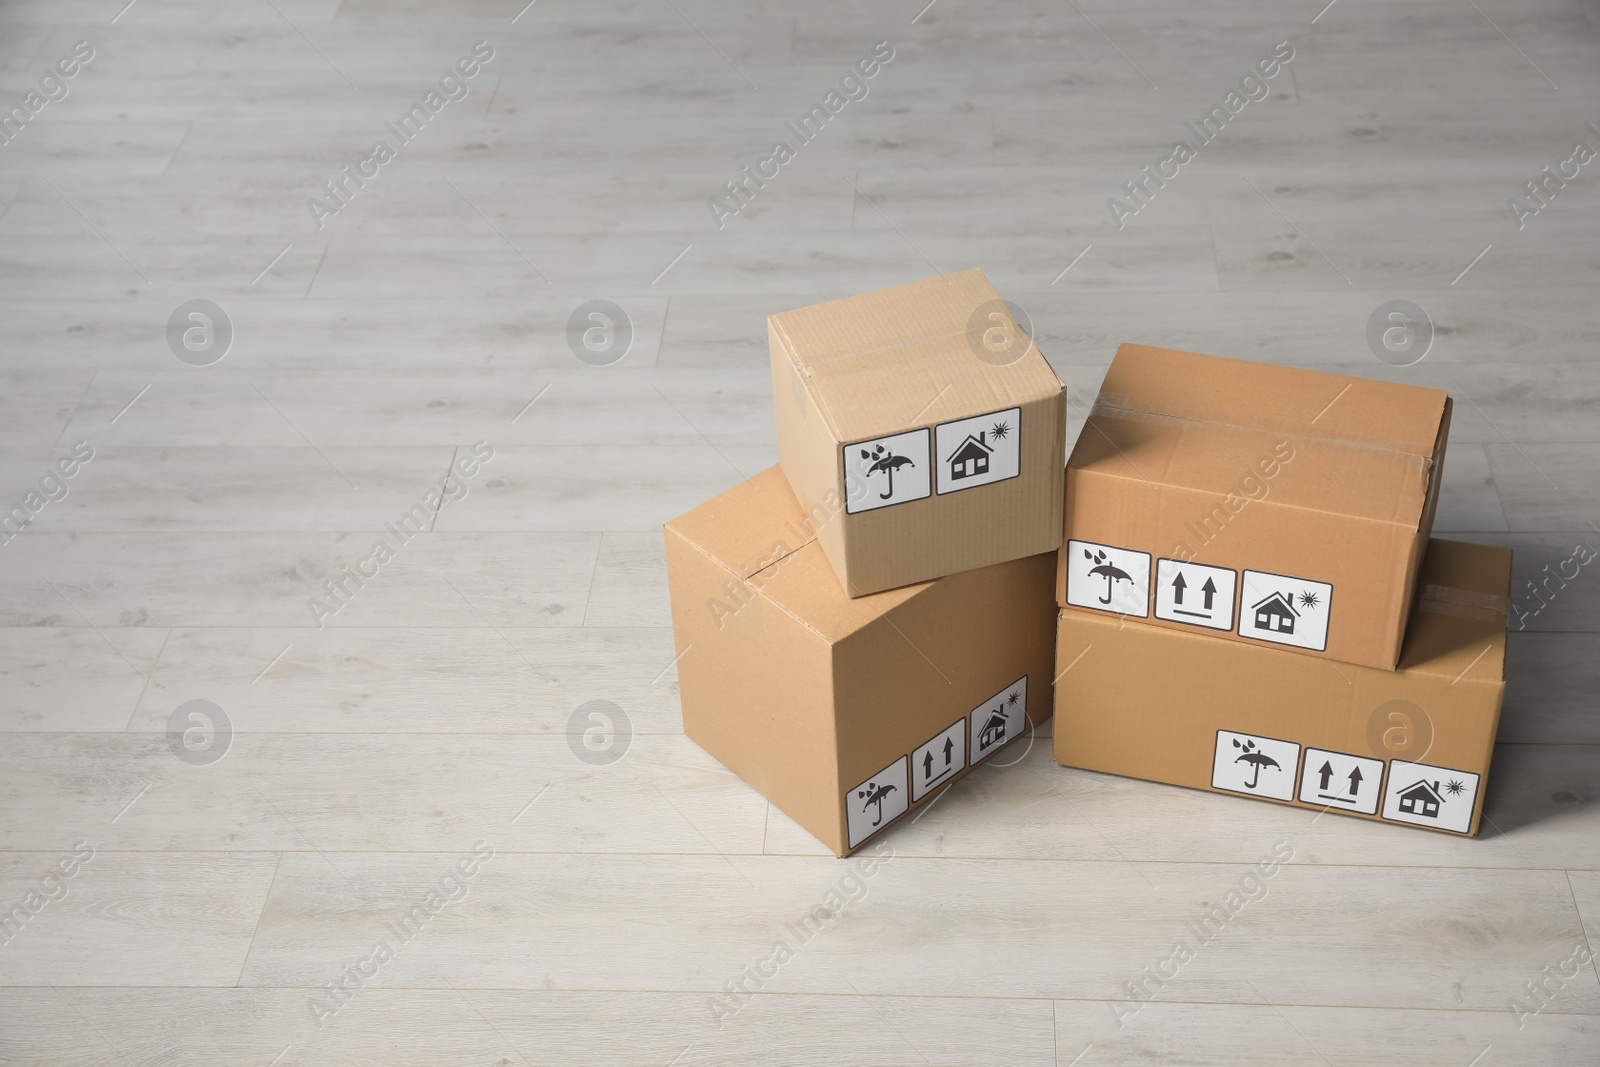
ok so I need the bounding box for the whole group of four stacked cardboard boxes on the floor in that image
[666,281,1510,856]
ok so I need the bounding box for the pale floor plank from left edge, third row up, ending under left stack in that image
[0,739,766,857]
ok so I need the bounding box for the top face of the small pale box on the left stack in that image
[770,270,1062,442]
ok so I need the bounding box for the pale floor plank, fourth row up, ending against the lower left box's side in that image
[126,627,683,736]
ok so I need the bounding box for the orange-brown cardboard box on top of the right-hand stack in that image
[1056,344,1450,669]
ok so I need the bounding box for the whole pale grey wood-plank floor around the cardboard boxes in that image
[0,0,1600,1067]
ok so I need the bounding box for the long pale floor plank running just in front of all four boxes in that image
[233,841,1600,1014]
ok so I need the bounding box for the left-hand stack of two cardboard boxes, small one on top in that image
[666,270,1066,856]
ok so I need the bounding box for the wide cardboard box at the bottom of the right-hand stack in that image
[1054,541,1510,835]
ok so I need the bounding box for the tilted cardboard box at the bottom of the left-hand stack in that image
[666,467,1056,856]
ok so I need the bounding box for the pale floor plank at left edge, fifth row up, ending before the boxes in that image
[0,531,600,633]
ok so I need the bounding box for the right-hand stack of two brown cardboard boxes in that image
[1054,344,1510,833]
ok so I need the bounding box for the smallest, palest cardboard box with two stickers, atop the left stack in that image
[766,270,1066,597]
